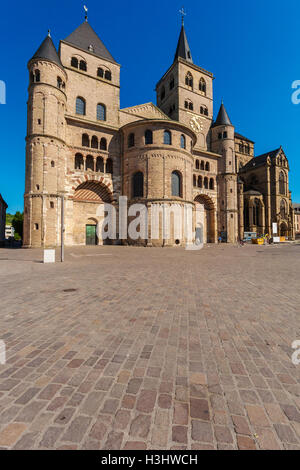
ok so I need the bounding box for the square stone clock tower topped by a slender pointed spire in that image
[156,18,213,150]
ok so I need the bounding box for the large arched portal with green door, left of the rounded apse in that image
[73,181,112,245]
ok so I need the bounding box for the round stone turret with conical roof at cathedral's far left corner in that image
[24,32,67,247]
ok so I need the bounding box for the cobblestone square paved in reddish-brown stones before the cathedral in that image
[0,244,300,450]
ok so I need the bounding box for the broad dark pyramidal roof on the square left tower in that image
[64,20,116,63]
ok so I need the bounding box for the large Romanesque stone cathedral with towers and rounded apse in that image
[24,18,294,247]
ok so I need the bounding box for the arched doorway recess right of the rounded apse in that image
[194,194,216,243]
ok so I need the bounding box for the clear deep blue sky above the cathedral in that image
[0,0,300,212]
